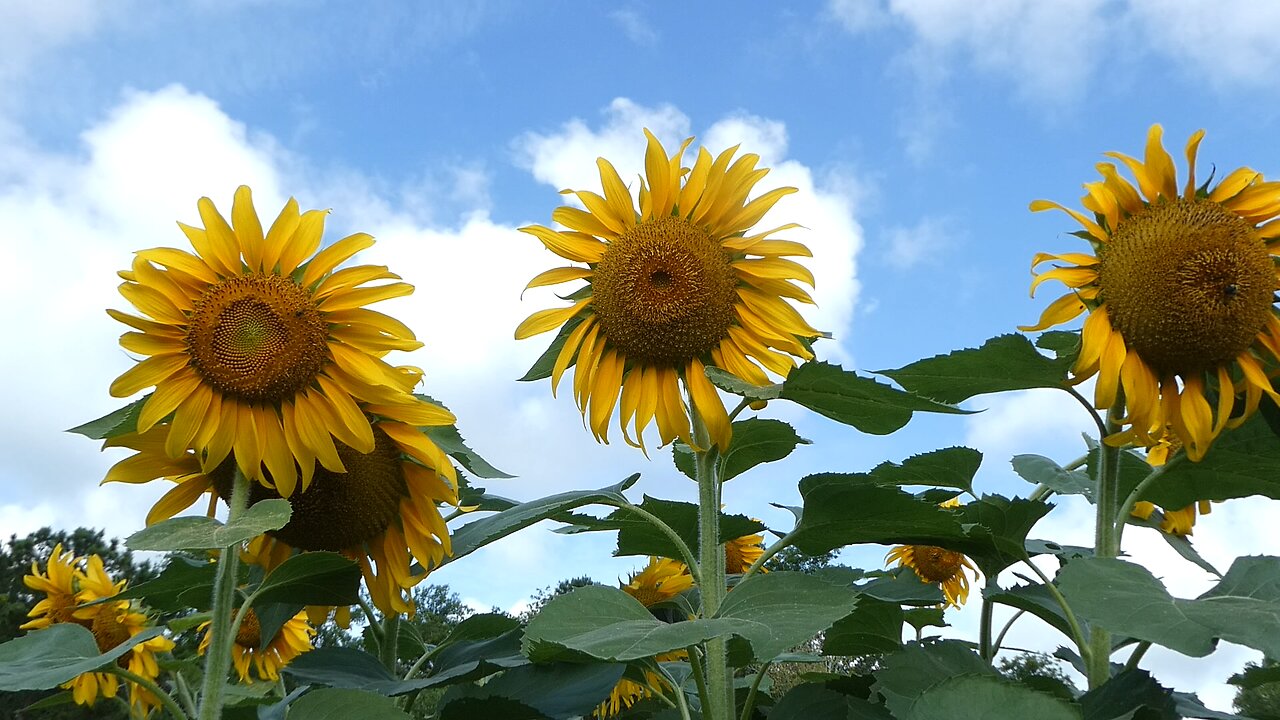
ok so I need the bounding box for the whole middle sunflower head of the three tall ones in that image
[516,131,819,448]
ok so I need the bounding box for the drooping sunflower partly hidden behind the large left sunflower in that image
[104,405,457,614]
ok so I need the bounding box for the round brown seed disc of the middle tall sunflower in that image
[591,218,737,366]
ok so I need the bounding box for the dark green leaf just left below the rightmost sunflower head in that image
[879,334,1071,404]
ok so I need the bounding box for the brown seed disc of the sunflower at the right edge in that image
[1098,200,1276,375]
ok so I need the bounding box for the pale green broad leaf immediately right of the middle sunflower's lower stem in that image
[716,571,858,662]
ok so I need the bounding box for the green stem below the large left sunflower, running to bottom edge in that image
[200,465,248,720]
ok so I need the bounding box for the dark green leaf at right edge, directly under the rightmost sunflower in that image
[1139,415,1280,510]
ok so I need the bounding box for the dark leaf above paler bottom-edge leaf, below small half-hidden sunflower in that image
[874,641,998,719]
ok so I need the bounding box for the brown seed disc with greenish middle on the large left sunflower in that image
[186,275,329,402]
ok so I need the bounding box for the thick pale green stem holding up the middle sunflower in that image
[689,402,733,720]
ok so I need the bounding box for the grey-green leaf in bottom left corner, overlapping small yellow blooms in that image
[0,623,164,692]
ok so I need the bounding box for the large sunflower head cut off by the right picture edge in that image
[1020,124,1280,460]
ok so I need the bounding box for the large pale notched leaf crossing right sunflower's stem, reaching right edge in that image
[1057,556,1280,657]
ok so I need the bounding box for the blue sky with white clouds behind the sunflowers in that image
[0,0,1280,707]
